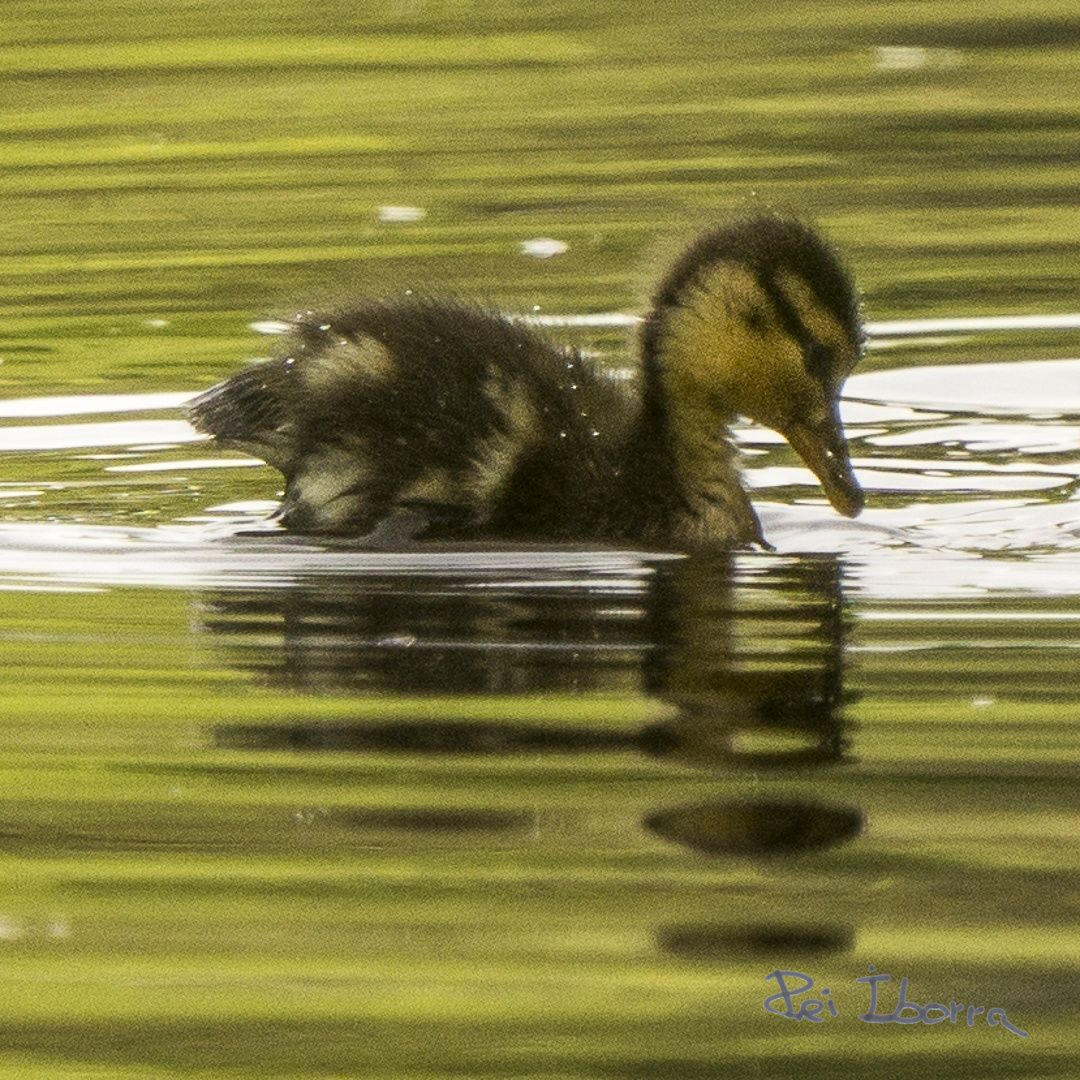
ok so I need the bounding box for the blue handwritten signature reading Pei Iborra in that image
[765,964,1027,1039]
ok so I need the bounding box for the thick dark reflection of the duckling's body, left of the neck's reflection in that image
[202,570,644,697]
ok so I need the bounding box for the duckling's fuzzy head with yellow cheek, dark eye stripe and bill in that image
[643,215,863,517]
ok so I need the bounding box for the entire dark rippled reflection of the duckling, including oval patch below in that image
[201,555,863,858]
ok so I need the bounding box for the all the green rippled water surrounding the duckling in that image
[0,0,1080,1080]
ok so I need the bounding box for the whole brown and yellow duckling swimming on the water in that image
[190,215,863,550]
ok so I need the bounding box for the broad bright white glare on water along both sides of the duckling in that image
[0,352,1080,597]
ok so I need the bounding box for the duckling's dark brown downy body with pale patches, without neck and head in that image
[192,297,634,540]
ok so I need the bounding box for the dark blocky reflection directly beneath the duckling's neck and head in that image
[644,557,848,769]
